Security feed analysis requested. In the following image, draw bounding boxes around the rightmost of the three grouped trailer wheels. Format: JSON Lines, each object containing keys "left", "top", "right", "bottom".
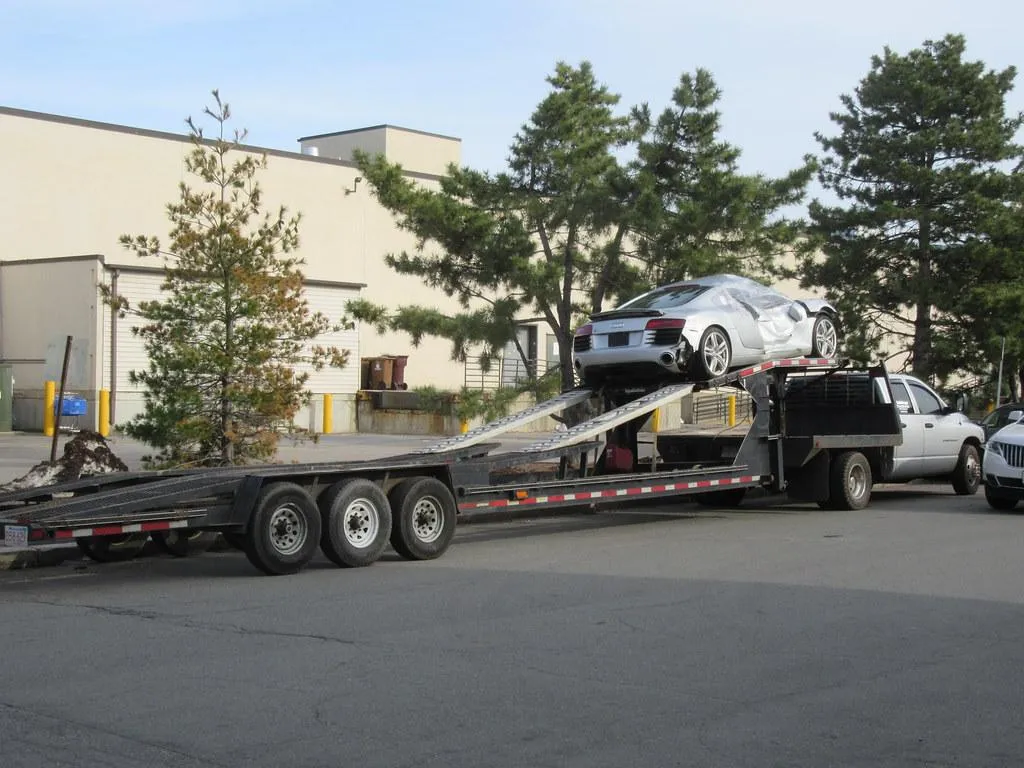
{"left": 389, "top": 477, "right": 456, "bottom": 560}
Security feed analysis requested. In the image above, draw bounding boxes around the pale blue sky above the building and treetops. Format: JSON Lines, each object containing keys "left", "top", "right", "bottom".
{"left": 0, "top": 0, "right": 1024, "bottom": 174}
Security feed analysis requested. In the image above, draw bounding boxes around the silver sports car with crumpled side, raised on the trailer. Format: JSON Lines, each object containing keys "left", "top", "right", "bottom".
{"left": 572, "top": 274, "right": 839, "bottom": 386}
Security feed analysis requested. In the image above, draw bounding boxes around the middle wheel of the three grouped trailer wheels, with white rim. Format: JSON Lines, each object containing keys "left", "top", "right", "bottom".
{"left": 316, "top": 477, "right": 391, "bottom": 568}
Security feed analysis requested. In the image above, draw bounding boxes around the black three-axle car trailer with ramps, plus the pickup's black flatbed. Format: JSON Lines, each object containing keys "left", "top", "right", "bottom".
{"left": 0, "top": 357, "right": 902, "bottom": 574}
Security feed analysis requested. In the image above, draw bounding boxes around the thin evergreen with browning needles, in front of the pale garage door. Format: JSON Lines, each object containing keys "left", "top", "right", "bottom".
{"left": 110, "top": 91, "right": 347, "bottom": 473}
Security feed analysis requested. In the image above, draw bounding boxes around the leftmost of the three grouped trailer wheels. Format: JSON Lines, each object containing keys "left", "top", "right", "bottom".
{"left": 246, "top": 482, "right": 321, "bottom": 575}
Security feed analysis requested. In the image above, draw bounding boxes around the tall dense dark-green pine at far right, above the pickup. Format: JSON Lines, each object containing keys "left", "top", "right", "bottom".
{"left": 805, "top": 35, "right": 1022, "bottom": 377}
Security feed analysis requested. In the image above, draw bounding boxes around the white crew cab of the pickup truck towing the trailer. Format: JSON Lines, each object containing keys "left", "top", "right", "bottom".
{"left": 881, "top": 374, "right": 983, "bottom": 496}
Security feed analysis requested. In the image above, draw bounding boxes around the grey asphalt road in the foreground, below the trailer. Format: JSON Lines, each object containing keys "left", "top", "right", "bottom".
{"left": 0, "top": 486, "right": 1024, "bottom": 768}
